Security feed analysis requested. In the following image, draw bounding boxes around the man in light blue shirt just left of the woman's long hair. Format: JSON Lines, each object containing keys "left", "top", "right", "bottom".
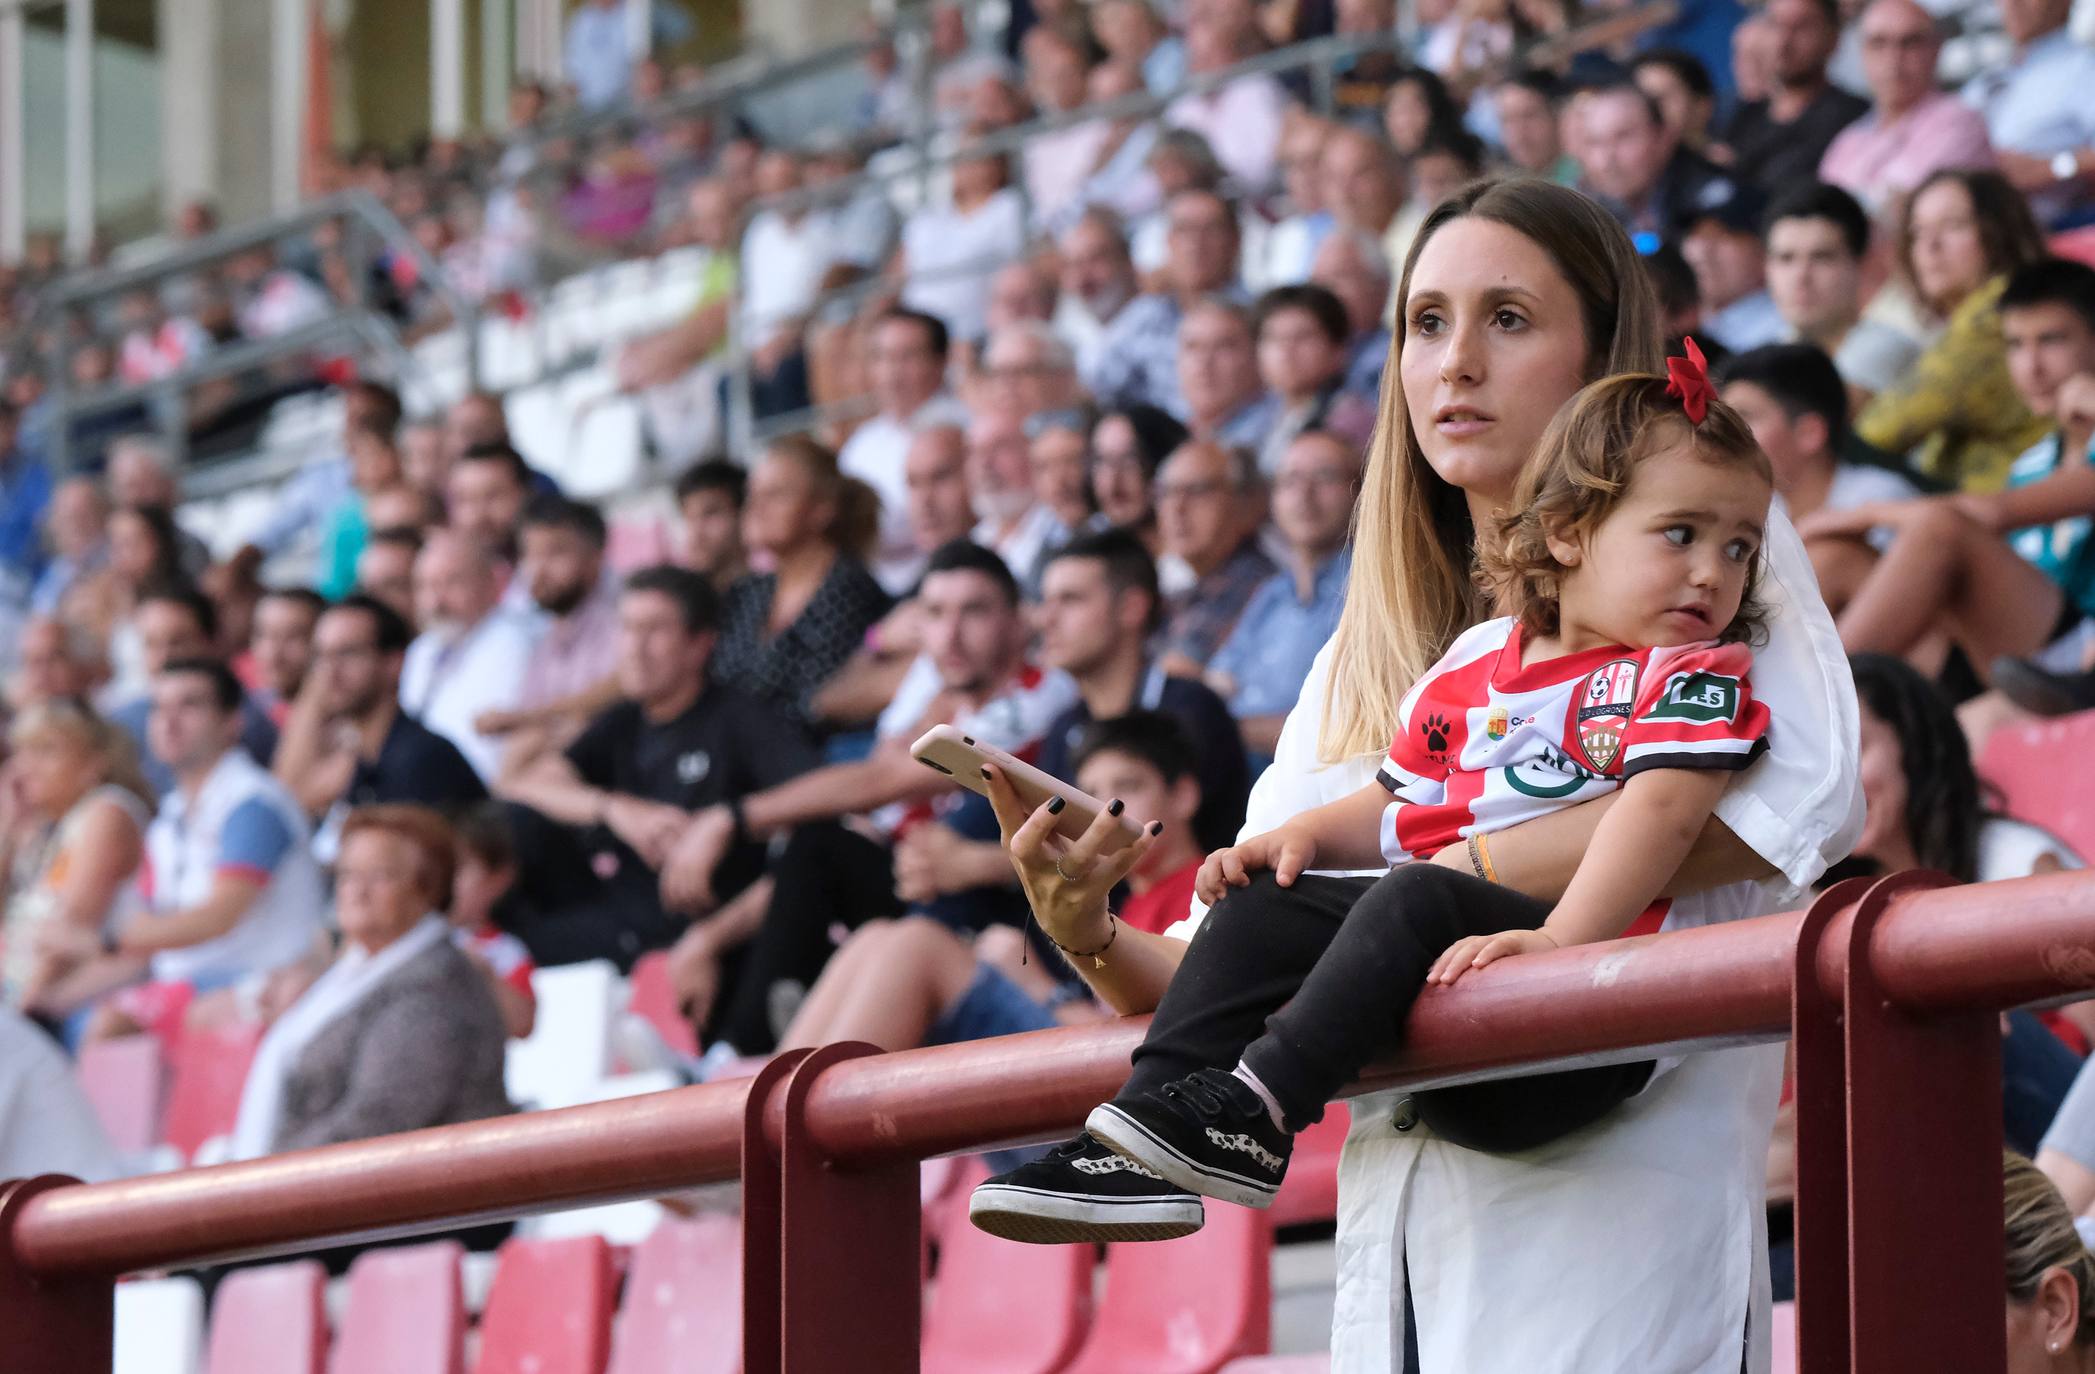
{"left": 1207, "top": 429, "right": 1362, "bottom": 760}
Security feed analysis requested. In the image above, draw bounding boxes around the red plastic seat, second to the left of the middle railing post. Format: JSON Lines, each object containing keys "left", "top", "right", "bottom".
{"left": 473, "top": 1236, "right": 618, "bottom": 1374}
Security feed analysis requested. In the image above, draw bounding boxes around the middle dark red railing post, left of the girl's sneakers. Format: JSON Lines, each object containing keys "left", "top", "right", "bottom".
{"left": 762, "top": 1043, "right": 924, "bottom": 1374}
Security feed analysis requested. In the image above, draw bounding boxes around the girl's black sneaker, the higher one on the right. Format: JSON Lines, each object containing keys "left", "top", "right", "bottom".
{"left": 1083, "top": 1068, "right": 1295, "bottom": 1206}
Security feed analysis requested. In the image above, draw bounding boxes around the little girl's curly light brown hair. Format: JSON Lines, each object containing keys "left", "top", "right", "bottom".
{"left": 1477, "top": 373, "right": 1774, "bottom": 643}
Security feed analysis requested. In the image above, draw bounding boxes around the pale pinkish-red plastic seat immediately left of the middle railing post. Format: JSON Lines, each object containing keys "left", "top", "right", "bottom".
{"left": 608, "top": 1217, "right": 742, "bottom": 1374}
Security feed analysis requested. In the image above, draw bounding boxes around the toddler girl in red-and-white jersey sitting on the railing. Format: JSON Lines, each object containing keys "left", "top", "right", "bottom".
{"left": 970, "top": 344, "right": 1772, "bottom": 1242}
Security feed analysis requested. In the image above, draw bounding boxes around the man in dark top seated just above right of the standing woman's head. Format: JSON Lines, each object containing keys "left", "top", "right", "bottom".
{"left": 1573, "top": 79, "right": 1743, "bottom": 239}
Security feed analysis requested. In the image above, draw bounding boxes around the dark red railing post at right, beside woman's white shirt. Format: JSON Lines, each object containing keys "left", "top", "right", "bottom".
{"left": 1843, "top": 873, "right": 2007, "bottom": 1374}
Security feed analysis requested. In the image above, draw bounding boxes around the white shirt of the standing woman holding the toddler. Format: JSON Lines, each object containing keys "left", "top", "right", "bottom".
{"left": 1169, "top": 513, "right": 1862, "bottom": 1374}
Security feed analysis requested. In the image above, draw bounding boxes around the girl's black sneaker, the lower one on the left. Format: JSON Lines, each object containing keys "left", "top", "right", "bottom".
{"left": 968, "top": 1135, "right": 1207, "bottom": 1244}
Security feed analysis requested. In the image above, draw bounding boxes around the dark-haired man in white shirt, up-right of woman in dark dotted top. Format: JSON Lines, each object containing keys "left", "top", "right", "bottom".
{"left": 836, "top": 308, "right": 966, "bottom": 591}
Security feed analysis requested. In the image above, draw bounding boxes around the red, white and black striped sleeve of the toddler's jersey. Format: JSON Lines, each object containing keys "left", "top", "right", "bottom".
{"left": 1622, "top": 643, "right": 1768, "bottom": 779}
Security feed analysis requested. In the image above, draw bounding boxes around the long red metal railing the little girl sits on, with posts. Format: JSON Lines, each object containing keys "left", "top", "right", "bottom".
{"left": 0, "top": 873, "right": 2095, "bottom": 1374}
